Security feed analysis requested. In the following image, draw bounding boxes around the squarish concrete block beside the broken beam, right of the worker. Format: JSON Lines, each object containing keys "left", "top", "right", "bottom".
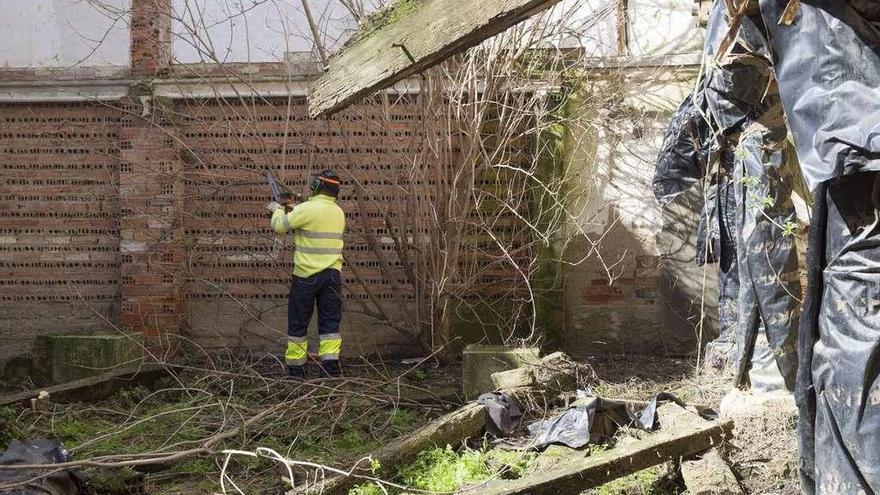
{"left": 462, "top": 345, "right": 540, "bottom": 400}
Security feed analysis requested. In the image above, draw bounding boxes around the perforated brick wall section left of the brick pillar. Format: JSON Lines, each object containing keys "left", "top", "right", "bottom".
{"left": 0, "top": 103, "right": 122, "bottom": 355}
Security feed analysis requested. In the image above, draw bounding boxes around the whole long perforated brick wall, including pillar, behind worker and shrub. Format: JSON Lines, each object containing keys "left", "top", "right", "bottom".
{"left": 0, "top": 91, "right": 526, "bottom": 357}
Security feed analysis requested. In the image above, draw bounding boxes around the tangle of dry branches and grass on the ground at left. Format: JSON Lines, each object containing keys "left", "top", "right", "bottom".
{"left": 0, "top": 363, "right": 439, "bottom": 494}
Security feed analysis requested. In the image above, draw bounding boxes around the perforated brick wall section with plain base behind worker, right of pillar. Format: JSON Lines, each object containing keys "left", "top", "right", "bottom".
{"left": 175, "top": 98, "right": 430, "bottom": 354}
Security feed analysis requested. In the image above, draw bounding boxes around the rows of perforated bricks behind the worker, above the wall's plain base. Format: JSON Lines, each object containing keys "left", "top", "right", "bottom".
{"left": 178, "top": 99, "right": 420, "bottom": 306}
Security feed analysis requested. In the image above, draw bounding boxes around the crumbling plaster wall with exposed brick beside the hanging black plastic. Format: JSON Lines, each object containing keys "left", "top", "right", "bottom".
{"left": 564, "top": 67, "right": 717, "bottom": 354}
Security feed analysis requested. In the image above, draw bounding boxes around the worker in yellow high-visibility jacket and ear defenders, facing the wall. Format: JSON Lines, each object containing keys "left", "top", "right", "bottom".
{"left": 269, "top": 170, "right": 345, "bottom": 378}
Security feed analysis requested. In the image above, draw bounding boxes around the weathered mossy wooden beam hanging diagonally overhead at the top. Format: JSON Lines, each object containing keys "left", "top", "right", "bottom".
{"left": 308, "top": 0, "right": 559, "bottom": 117}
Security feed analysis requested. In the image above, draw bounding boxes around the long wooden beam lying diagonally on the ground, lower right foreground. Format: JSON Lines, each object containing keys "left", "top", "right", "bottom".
{"left": 463, "top": 404, "right": 733, "bottom": 495}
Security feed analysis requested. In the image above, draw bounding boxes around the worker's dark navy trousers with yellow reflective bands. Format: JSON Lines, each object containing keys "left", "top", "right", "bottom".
{"left": 287, "top": 268, "right": 342, "bottom": 364}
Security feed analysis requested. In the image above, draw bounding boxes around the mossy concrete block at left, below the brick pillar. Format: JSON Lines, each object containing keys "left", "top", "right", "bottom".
{"left": 34, "top": 334, "right": 144, "bottom": 383}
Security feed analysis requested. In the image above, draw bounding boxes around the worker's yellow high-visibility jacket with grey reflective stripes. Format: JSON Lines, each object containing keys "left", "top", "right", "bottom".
{"left": 272, "top": 194, "right": 345, "bottom": 277}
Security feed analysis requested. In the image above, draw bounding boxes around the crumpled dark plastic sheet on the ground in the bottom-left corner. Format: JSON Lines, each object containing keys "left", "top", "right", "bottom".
{"left": 0, "top": 440, "right": 80, "bottom": 495}
